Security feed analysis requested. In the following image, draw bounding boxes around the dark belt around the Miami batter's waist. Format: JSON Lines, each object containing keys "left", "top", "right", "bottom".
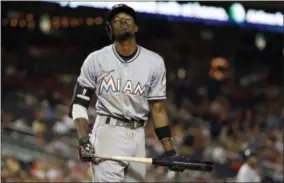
{"left": 103, "top": 116, "right": 146, "bottom": 129}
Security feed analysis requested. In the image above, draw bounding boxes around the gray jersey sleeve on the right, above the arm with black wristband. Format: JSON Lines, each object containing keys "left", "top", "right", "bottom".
{"left": 148, "top": 59, "right": 167, "bottom": 100}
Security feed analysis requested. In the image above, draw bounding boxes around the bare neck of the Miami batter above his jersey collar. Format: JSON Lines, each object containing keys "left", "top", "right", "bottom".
{"left": 114, "top": 39, "right": 137, "bottom": 56}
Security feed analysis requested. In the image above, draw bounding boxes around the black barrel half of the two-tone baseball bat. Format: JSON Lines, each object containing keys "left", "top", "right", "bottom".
{"left": 153, "top": 158, "right": 214, "bottom": 172}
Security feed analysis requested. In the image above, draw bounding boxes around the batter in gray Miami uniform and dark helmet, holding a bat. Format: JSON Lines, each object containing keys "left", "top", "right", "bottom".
{"left": 69, "top": 4, "right": 184, "bottom": 182}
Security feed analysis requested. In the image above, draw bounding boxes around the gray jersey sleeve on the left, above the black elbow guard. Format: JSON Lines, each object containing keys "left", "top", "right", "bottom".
{"left": 78, "top": 54, "right": 97, "bottom": 89}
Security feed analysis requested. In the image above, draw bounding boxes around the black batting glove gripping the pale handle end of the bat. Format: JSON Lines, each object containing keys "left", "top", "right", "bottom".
{"left": 79, "top": 136, "right": 95, "bottom": 162}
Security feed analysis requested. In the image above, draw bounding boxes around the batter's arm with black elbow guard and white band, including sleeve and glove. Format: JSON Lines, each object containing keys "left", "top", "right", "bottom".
{"left": 69, "top": 54, "right": 96, "bottom": 162}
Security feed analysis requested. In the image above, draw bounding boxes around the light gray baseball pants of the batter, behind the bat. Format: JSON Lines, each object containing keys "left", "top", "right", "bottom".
{"left": 90, "top": 115, "right": 146, "bottom": 182}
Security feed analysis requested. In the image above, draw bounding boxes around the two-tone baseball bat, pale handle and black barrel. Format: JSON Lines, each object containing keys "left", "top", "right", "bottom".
{"left": 93, "top": 154, "right": 214, "bottom": 172}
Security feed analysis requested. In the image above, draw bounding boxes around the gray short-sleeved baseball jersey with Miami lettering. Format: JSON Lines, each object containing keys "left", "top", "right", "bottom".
{"left": 78, "top": 44, "right": 166, "bottom": 120}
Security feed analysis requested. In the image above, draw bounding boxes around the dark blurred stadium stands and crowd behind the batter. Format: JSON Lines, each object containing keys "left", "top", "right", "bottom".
{"left": 1, "top": 2, "right": 284, "bottom": 182}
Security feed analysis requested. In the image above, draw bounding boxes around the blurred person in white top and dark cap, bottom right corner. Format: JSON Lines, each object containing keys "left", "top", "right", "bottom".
{"left": 236, "top": 149, "right": 261, "bottom": 182}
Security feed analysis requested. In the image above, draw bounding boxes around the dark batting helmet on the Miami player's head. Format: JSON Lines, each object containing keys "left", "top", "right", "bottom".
{"left": 106, "top": 4, "right": 136, "bottom": 41}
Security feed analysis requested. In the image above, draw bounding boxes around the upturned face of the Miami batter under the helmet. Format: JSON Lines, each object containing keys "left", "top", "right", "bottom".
{"left": 112, "top": 13, "right": 138, "bottom": 39}
